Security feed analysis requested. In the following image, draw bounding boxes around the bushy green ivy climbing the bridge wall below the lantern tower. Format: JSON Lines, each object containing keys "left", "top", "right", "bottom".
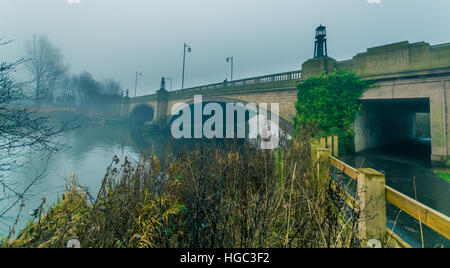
{"left": 294, "top": 71, "right": 373, "bottom": 154}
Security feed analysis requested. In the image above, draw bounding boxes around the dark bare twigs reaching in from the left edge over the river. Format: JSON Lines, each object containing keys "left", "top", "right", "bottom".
{"left": 0, "top": 38, "right": 73, "bottom": 231}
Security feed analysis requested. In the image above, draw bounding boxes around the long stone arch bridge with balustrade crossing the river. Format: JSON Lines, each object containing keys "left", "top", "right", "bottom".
{"left": 120, "top": 41, "right": 450, "bottom": 164}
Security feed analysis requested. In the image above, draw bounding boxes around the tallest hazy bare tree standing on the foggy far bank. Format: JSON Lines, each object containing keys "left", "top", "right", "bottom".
{"left": 26, "top": 35, "right": 68, "bottom": 101}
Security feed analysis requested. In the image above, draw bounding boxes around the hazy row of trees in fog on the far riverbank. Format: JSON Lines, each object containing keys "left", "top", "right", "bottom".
{"left": 26, "top": 35, "right": 124, "bottom": 107}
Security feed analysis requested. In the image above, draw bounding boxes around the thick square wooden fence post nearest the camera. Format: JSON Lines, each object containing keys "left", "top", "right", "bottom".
{"left": 358, "top": 168, "right": 386, "bottom": 247}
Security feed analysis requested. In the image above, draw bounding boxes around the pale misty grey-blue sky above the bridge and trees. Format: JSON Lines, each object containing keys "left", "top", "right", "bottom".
{"left": 0, "top": 0, "right": 450, "bottom": 95}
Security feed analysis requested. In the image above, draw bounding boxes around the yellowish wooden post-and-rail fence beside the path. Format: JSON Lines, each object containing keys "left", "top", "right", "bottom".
{"left": 311, "top": 136, "right": 450, "bottom": 248}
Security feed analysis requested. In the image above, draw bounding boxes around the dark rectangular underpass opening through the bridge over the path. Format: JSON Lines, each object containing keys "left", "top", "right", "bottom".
{"left": 355, "top": 98, "right": 431, "bottom": 165}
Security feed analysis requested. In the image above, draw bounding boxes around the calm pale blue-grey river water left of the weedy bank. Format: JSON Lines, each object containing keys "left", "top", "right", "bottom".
{"left": 0, "top": 122, "right": 156, "bottom": 235}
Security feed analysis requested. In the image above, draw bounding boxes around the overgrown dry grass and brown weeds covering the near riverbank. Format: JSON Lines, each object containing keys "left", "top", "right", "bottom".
{"left": 0, "top": 133, "right": 359, "bottom": 248}
